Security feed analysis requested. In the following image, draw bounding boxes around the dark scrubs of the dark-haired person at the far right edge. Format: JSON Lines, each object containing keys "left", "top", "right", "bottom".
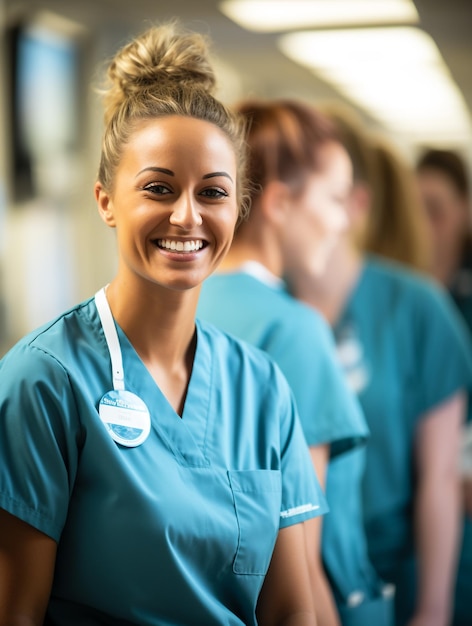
{"left": 450, "top": 257, "right": 472, "bottom": 626}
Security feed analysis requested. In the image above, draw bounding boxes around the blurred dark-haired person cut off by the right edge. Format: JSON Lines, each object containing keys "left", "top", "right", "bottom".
{"left": 416, "top": 148, "right": 472, "bottom": 626}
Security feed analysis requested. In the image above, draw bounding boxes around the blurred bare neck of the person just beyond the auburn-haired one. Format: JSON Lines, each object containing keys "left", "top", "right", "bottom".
{"left": 289, "top": 238, "right": 363, "bottom": 325}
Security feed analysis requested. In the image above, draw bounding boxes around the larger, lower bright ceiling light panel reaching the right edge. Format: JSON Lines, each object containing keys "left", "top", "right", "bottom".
{"left": 279, "top": 27, "right": 471, "bottom": 141}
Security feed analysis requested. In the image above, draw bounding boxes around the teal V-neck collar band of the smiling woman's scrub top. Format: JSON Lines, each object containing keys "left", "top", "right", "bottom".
{"left": 115, "top": 321, "right": 212, "bottom": 467}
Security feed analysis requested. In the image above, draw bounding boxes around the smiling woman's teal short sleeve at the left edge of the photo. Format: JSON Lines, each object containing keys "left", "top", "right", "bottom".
{"left": 0, "top": 344, "right": 80, "bottom": 540}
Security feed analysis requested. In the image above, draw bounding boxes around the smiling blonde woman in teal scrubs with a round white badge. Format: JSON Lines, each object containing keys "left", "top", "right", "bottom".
{"left": 0, "top": 19, "right": 327, "bottom": 626}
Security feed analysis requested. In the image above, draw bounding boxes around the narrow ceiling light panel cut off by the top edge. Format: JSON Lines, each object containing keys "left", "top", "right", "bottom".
{"left": 219, "top": 0, "right": 419, "bottom": 32}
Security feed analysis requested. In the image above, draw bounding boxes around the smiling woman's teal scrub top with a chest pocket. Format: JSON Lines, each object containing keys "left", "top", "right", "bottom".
{"left": 0, "top": 300, "right": 327, "bottom": 626}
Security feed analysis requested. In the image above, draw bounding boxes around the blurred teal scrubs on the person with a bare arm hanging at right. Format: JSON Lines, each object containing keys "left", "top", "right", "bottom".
{"left": 334, "top": 258, "right": 472, "bottom": 625}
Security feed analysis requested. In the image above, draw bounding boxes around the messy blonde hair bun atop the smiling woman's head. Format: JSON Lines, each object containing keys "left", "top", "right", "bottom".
{"left": 108, "top": 22, "right": 215, "bottom": 103}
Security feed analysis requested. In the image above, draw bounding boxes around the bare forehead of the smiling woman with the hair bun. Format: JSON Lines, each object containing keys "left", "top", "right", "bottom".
{"left": 122, "top": 115, "right": 236, "bottom": 175}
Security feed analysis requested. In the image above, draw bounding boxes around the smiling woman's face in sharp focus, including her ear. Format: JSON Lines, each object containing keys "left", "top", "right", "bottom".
{"left": 96, "top": 116, "right": 238, "bottom": 290}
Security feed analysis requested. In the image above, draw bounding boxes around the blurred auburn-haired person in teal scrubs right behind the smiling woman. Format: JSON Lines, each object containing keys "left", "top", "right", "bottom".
{"left": 198, "top": 100, "right": 392, "bottom": 626}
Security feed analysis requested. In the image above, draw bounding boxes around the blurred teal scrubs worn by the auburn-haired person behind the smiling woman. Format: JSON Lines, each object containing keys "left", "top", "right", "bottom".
{"left": 197, "top": 262, "right": 392, "bottom": 626}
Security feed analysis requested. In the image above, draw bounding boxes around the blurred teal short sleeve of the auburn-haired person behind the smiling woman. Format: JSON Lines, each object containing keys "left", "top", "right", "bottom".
{"left": 268, "top": 307, "right": 368, "bottom": 458}
